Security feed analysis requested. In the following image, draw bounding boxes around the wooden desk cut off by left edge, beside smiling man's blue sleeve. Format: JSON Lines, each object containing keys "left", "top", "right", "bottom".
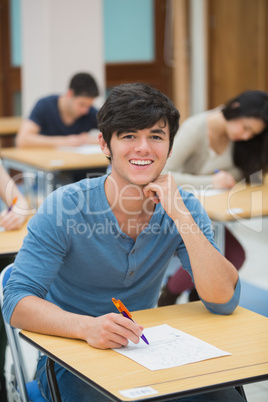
{"left": 0, "top": 220, "right": 28, "bottom": 257}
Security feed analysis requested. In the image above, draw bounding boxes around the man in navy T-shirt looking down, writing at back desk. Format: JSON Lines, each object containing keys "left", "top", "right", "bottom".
{"left": 16, "top": 73, "right": 99, "bottom": 147}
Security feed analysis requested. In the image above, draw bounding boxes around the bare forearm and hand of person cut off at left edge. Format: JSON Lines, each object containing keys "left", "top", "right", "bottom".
{"left": 0, "top": 165, "right": 29, "bottom": 230}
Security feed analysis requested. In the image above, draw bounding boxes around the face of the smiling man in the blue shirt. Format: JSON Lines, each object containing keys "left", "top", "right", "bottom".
{"left": 103, "top": 121, "right": 170, "bottom": 186}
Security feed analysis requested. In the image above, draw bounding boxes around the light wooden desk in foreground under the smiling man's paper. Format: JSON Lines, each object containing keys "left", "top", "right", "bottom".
{"left": 20, "top": 302, "right": 268, "bottom": 401}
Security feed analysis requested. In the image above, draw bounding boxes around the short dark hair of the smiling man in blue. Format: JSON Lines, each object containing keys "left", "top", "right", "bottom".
{"left": 97, "top": 83, "right": 180, "bottom": 155}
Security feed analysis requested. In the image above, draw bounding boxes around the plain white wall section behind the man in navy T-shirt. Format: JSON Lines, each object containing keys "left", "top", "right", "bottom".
{"left": 21, "top": 0, "right": 105, "bottom": 116}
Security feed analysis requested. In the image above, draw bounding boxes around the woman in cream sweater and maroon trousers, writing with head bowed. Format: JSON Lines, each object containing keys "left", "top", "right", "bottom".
{"left": 158, "top": 90, "right": 268, "bottom": 306}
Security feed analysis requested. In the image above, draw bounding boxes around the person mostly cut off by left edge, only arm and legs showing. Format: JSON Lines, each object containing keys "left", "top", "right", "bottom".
{"left": 0, "top": 160, "right": 29, "bottom": 402}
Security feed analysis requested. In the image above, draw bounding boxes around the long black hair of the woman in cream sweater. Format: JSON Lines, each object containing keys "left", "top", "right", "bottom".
{"left": 222, "top": 90, "right": 268, "bottom": 182}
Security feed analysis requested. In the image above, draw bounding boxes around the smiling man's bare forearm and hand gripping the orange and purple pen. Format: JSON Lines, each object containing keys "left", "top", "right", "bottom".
{"left": 10, "top": 296, "right": 143, "bottom": 349}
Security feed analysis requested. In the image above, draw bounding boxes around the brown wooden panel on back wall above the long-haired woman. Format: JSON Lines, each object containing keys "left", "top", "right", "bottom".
{"left": 208, "top": 0, "right": 268, "bottom": 108}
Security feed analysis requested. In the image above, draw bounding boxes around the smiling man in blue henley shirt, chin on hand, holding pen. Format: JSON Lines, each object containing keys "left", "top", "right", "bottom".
{"left": 3, "top": 84, "right": 244, "bottom": 402}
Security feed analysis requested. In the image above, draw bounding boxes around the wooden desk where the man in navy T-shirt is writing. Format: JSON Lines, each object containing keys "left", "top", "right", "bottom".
{"left": 1, "top": 148, "right": 109, "bottom": 197}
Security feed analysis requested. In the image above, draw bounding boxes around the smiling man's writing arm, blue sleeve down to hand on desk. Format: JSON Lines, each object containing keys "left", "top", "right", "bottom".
{"left": 3, "top": 192, "right": 143, "bottom": 349}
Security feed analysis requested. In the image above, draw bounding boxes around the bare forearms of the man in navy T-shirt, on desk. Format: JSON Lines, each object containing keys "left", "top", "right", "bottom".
{"left": 16, "top": 119, "right": 99, "bottom": 148}
